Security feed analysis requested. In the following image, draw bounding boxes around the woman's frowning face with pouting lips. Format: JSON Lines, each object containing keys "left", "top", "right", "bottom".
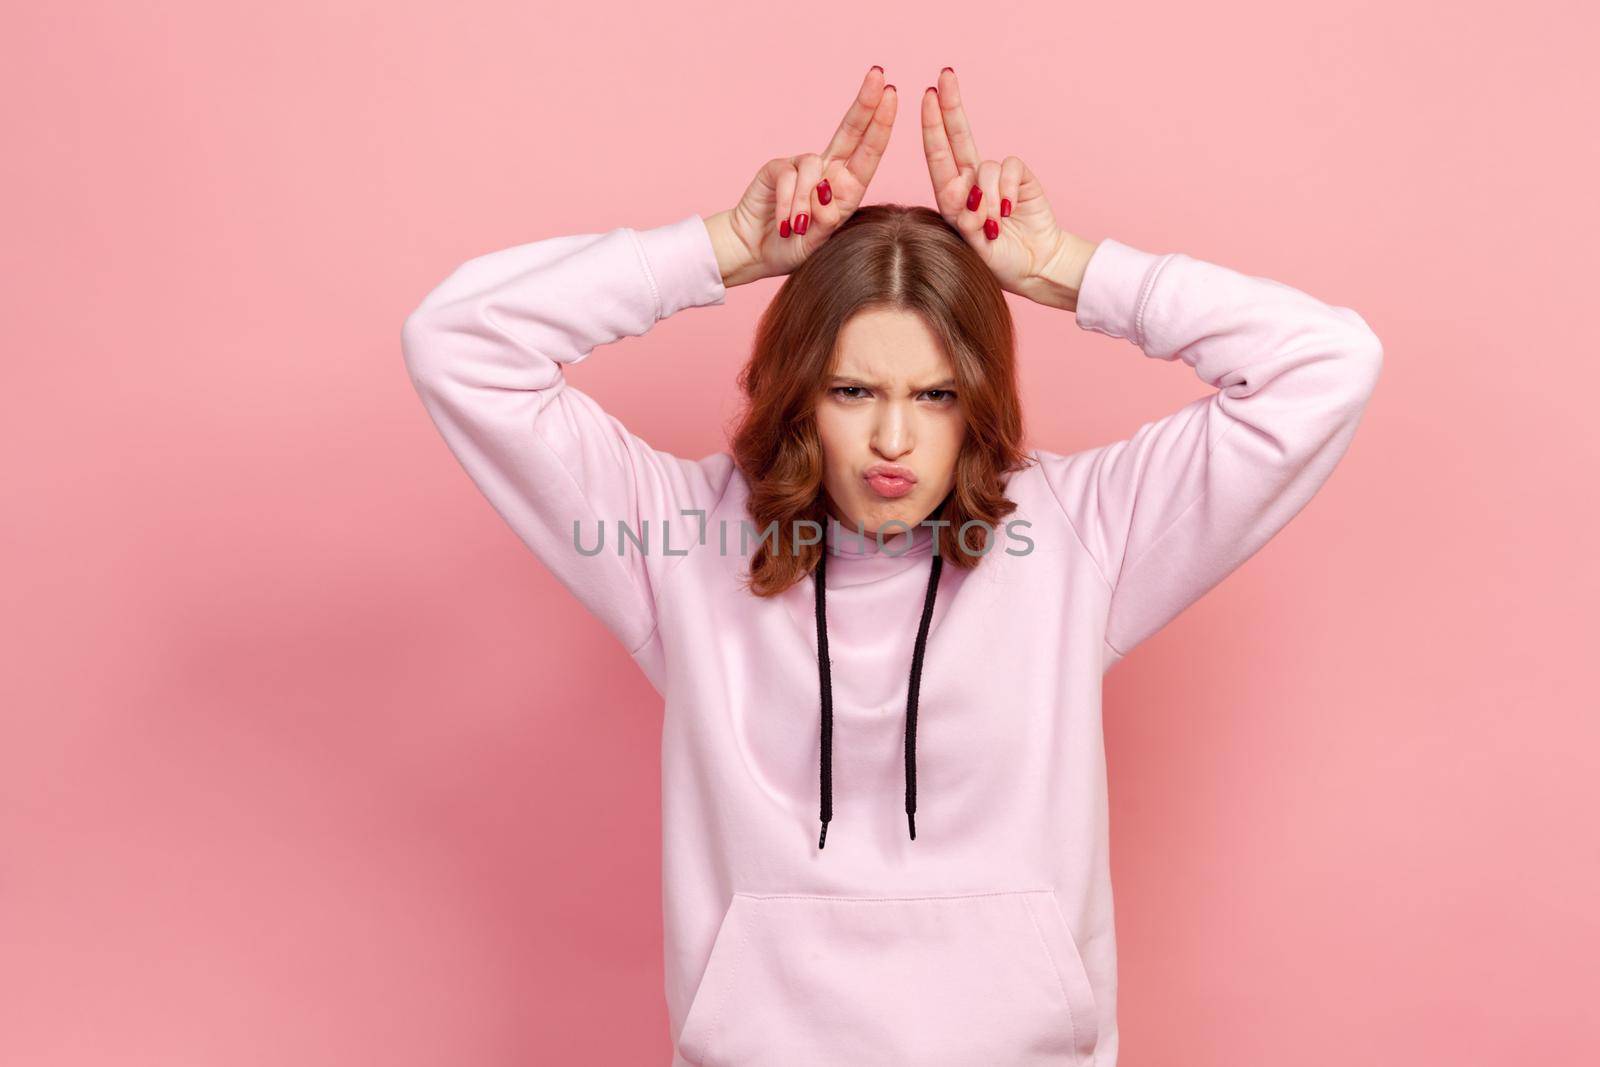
{"left": 816, "top": 309, "right": 966, "bottom": 545}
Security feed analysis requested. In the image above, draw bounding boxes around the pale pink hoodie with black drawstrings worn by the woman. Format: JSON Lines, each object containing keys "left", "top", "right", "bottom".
{"left": 403, "top": 216, "right": 1382, "bottom": 1067}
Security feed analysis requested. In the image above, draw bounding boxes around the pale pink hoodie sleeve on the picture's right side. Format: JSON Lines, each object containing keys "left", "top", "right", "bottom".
{"left": 1040, "top": 240, "right": 1382, "bottom": 667}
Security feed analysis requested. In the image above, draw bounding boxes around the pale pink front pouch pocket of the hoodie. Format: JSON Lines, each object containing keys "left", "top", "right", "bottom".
{"left": 678, "top": 889, "right": 1098, "bottom": 1067}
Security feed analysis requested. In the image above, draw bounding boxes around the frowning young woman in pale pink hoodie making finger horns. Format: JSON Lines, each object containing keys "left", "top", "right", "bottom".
{"left": 405, "top": 67, "right": 1382, "bottom": 1067}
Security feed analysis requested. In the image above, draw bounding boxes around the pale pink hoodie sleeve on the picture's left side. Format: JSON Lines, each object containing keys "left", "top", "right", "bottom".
{"left": 402, "top": 214, "right": 733, "bottom": 656}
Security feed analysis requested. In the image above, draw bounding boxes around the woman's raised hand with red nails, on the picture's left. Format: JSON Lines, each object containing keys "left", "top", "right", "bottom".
{"left": 706, "top": 67, "right": 896, "bottom": 288}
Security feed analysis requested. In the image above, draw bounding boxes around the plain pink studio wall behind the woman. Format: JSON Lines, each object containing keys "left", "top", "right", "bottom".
{"left": 0, "top": 0, "right": 1600, "bottom": 1067}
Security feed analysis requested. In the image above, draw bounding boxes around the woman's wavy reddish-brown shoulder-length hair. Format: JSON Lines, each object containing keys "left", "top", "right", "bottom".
{"left": 731, "top": 203, "right": 1027, "bottom": 597}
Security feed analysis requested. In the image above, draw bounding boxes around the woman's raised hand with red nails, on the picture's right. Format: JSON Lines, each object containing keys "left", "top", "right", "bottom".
{"left": 922, "top": 67, "right": 1096, "bottom": 310}
